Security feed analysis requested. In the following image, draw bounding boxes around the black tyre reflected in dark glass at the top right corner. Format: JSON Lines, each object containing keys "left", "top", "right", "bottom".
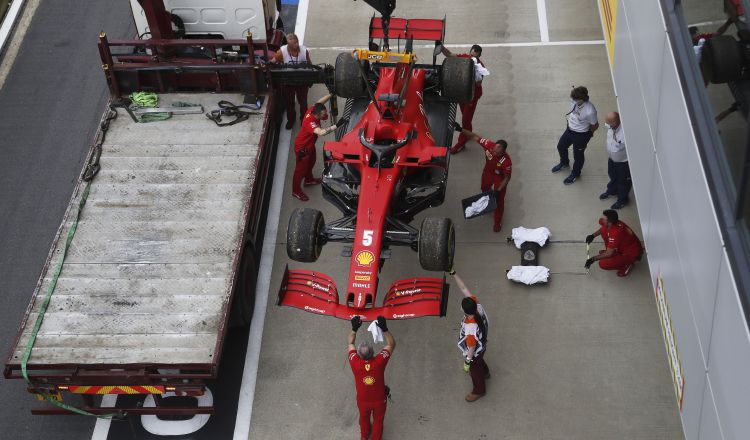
{"left": 701, "top": 35, "right": 742, "bottom": 84}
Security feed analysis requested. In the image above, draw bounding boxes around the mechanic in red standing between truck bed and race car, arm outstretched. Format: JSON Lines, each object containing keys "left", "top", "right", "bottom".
{"left": 292, "top": 95, "right": 349, "bottom": 202}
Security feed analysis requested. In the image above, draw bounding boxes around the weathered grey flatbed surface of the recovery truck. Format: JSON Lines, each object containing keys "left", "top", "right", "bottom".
{"left": 6, "top": 93, "right": 266, "bottom": 370}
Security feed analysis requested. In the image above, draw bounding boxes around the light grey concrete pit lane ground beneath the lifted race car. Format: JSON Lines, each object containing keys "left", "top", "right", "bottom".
{"left": 250, "top": 0, "right": 682, "bottom": 439}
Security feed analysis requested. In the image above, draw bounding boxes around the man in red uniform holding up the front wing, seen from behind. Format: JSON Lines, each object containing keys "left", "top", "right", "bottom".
{"left": 348, "top": 316, "right": 396, "bottom": 440}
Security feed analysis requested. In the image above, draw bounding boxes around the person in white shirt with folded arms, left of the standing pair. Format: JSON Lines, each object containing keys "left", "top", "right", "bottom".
{"left": 552, "top": 86, "right": 599, "bottom": 185}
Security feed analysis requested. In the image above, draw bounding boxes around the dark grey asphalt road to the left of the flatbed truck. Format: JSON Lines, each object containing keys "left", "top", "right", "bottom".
{"left": 0, "top": 0, "right": 129, "bottom": 440}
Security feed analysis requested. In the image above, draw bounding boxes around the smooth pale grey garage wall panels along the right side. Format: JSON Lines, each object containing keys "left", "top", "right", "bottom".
{"left": 599, "top": 0, "right": 750, "bottom": 440}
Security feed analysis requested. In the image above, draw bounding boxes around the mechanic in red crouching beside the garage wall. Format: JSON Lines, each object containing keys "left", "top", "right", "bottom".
{"left": 584, "top": 209, "right": 643, "bottom": 277}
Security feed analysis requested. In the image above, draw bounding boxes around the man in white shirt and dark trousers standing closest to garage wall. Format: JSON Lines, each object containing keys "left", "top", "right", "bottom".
{"left": 599, "top": 112, "right": 633, "bottom": 209}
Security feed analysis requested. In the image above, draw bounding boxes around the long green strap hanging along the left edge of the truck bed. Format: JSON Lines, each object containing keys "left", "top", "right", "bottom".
{"left": 21, "top": 182, "right": 115, "bottom": 419}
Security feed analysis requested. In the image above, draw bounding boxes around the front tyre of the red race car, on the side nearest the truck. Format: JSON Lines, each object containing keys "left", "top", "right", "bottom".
{"left": 286, "top": 208, "right": 325, "bottom": 263}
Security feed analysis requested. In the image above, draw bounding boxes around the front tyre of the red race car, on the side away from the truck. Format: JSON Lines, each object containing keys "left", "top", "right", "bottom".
{"left": 418, "top": 217, "right": 456, "bottom": 271}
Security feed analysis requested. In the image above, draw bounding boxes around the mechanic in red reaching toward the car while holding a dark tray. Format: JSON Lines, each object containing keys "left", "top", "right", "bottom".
{"left": 453, "top": 122, "right": 513, "bottom": 232}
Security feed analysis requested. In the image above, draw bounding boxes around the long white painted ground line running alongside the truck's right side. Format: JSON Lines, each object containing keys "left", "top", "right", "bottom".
{"left": 234, "top": 117, "right": 302, "bottom": 440}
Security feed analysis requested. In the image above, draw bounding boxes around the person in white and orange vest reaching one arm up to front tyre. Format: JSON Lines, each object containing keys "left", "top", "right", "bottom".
{"left": 448, "top": 270, "right": 490, "bottom": 402}
